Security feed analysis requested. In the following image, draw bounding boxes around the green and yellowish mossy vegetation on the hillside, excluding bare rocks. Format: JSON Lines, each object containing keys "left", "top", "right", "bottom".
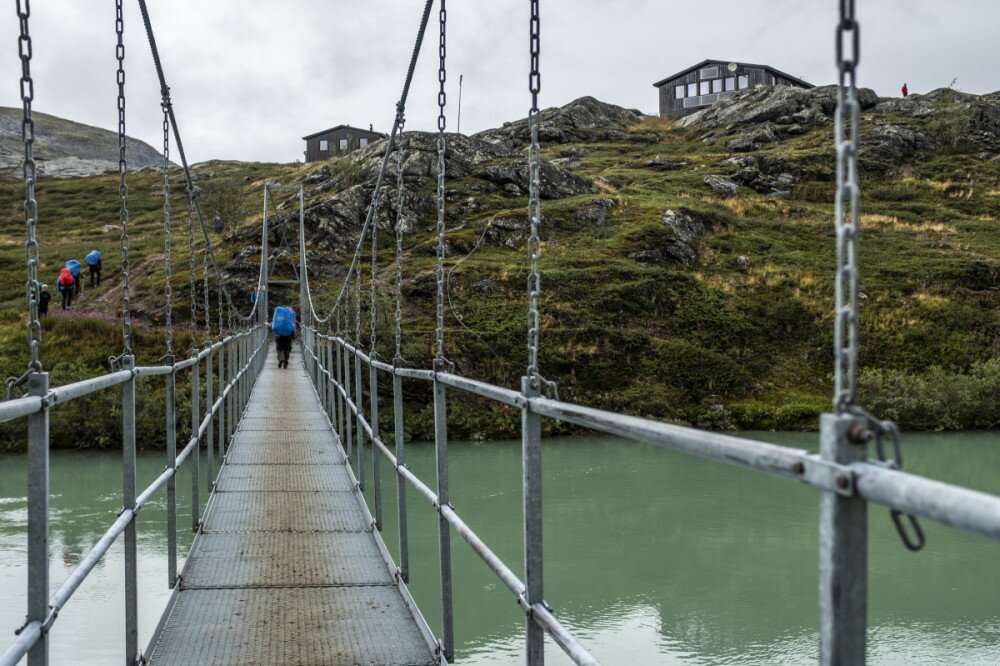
{"left": 0, "top": 110, "right": 1000, "bottom": 447}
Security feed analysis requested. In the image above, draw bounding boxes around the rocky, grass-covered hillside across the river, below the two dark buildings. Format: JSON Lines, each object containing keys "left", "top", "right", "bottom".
{"left": 0, "top": 88, "right": 1000, "bottom": 442}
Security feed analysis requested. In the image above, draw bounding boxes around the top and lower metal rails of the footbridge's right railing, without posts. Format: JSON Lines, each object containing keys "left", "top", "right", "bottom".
{"left": 303, "top": 327, "right": 1000, "bottom": 664}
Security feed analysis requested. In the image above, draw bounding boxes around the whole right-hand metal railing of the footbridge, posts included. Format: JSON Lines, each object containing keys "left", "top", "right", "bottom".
{"left": 302, "top": 327, "right": 1000, "bottom": 664}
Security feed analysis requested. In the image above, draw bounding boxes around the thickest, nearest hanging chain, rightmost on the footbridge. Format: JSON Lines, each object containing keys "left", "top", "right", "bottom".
{"left": 833, "top": 0, "right": 860, "bottom": 414}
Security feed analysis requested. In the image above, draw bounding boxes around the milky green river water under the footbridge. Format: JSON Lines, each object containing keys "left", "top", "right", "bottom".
{"left": 0, "top": 433, "right": 1000, "bottom": 666}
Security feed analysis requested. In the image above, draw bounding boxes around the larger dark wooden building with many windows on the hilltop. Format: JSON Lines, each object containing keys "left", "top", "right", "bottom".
{"left": 653, "top": 60, "right": 814, "bottom": 117}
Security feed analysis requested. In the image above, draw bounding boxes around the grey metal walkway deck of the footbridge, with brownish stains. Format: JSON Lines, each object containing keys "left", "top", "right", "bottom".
{"left": 149, "top": 353, "right": 437, "bottom": 666}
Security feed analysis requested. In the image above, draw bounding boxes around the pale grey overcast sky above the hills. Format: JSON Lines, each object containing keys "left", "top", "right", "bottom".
{"left": 0, "top": 0, "right": 1000, "bottom": 162}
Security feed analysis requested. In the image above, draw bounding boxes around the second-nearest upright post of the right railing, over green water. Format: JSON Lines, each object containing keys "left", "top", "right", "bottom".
{"left": 521, "top": 377, "right": 545, "bottom": 666}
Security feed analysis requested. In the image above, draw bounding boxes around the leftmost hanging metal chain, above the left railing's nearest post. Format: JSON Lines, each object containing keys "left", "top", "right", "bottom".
{"left": 16, "top": 0, "right": 42, "bottom": 374}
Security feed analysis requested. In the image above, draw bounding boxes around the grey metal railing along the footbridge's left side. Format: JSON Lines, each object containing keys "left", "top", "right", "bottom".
{"left": 0, "top": 325, "right": 267, "bottom": 666}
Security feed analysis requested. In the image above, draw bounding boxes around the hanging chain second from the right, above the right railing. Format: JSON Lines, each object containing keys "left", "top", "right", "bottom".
{"left": 527, "top": 0, "right": 556, "bottom": 393}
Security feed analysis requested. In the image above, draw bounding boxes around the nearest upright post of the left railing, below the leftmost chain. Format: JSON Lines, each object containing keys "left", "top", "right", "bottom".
{"left": 27, "top": 372, "right": 49, "bottom": 666}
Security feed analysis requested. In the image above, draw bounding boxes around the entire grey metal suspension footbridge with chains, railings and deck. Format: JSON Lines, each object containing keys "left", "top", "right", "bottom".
{"left": 0, "top": 0, "right": 1000, "bottom": 666}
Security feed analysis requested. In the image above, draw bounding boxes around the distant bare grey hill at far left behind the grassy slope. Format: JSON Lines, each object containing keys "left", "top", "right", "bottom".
{"left": 0, "top": 107, "right": 163, "bottom": 178}
